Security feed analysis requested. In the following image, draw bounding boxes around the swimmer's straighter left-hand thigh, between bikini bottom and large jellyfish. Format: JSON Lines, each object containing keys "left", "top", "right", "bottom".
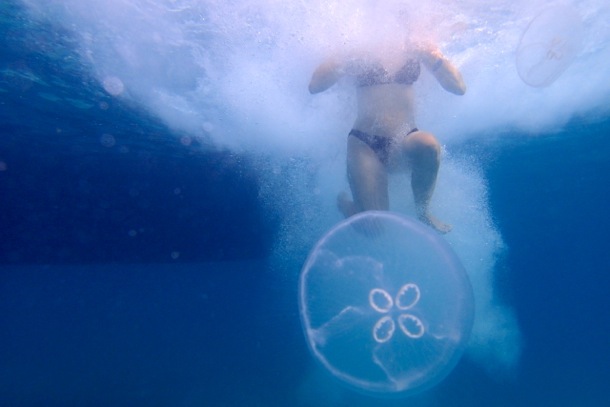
{"left": 347, "top": 136, "right": 389, "bottom": 211}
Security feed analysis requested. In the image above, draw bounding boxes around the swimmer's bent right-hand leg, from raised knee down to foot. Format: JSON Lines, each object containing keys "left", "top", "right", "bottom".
{"left": 398, "top": 131, "right": 451, "bottom": 233}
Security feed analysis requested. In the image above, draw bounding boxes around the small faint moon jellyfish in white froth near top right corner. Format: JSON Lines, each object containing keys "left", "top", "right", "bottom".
{"left": 516, "top": 6, "right": 583, "bottom": 87}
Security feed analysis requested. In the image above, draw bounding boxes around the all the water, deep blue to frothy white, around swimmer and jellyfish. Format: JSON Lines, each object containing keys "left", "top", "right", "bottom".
{"left": 0, "top": 0, "right": 610, "bottom": 407}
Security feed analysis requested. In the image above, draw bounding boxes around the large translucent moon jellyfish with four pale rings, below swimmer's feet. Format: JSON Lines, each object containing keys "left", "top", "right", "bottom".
{"left": 299, "top": 211, "right": 474, "bottom": 396}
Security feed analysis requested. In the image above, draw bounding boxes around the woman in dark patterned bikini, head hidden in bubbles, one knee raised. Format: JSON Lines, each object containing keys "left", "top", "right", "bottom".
{"left": 309, "top": 44, "right": 466, "bottom": 233}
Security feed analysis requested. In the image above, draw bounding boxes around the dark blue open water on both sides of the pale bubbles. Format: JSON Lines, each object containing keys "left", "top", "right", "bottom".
{"left": 0, "top": 2, "right": 610, "bottom": 407}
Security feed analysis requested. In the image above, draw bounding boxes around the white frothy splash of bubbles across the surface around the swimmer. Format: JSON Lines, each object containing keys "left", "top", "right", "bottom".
{"left": 23, "top": 0, "right": 610, "bottom": 145}
